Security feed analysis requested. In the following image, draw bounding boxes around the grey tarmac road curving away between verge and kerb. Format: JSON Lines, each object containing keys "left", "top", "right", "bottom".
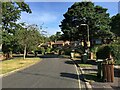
{"left": 2, "top": 57, "right": 79, "bottom": 88}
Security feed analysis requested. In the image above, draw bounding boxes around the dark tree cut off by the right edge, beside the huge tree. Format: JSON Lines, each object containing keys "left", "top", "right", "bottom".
{"left": 110, "top": 14, "right": 120, "bottom": 37}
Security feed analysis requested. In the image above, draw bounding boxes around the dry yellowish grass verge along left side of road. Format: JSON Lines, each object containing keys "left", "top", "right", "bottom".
{"left": 0, "top": 58, "right": 41, "bottom": 74}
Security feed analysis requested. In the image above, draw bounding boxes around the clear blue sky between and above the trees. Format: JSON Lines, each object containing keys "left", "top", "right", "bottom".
{"left": 19, "top": 2, "right": 118, "bottom": 35}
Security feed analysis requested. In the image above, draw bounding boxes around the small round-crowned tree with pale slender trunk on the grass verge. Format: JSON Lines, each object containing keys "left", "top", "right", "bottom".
{"left": 15, "top": 25, "right": 41, "bottom": 59}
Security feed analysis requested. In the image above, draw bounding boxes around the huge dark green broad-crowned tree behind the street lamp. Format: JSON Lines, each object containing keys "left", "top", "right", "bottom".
{"left": 60, "top": 2, "right": 111, "bottom": 41}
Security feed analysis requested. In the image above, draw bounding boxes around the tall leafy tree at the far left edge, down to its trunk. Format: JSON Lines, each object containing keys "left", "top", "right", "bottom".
{"left": 1, "top": 1, "right": 31, "bottom": 58}
